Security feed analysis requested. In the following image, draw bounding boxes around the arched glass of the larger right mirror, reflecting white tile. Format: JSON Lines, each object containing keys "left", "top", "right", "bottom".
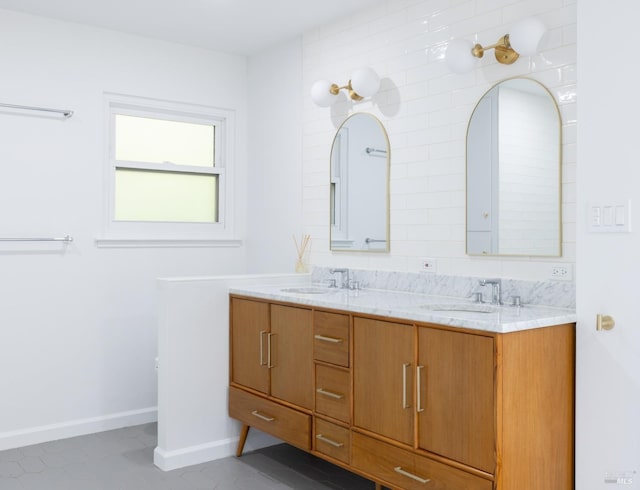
{"left": 467, "top": 78, "right": 562, "bottom": 256}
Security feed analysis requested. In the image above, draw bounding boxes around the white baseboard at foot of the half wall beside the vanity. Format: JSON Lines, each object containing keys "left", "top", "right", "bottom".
{"left": 153, "top": 429, "right": 282, "bottom": 471}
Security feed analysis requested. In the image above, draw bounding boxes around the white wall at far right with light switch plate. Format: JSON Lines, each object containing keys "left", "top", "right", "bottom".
{"left": 576, "top": 0, "right": 640, "bottom": 490}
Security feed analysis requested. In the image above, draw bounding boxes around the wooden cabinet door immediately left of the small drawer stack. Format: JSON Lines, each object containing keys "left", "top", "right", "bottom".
{"left": 270, "top": 305, "right": 313, "bottom": 410}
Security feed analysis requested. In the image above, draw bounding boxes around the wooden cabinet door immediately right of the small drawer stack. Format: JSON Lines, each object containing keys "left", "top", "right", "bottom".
{"left": 353, "top": 318, "right": 415, "bottom": 445}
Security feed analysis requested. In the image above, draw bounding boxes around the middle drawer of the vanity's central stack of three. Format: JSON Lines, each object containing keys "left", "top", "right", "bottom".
{"left": 315, "top": 364, "right": 351, "bottom": 422}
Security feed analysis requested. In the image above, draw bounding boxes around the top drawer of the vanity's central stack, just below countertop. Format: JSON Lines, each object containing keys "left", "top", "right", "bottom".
{"left": 313, "top": 311, "right": 349, "bottom": 367}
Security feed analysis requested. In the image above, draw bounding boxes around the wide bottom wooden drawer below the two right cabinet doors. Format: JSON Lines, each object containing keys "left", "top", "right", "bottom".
{"left": 351, "top": 433, "right": 493, "bottom": 490}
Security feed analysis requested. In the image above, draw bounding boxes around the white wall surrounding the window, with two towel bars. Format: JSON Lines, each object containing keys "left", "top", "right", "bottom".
{"left": 0, "top": 11, "right": 247, "bottom": 449}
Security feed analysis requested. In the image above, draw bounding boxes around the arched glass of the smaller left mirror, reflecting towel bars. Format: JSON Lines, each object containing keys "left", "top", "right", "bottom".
{"left": 330, "top": 113, "right": 390, "bottom": 252}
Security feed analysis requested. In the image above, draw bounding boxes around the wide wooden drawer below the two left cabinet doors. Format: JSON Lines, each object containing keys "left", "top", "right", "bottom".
{"left": 229, "top": 387, "right": 311, "bottom": 451}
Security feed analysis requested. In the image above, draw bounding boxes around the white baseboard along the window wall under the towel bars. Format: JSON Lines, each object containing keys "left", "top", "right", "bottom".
{"left": 0, "top": 407, "right": 158, "bottom": 451}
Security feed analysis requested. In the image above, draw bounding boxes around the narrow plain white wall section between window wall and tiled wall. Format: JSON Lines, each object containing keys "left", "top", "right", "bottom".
{"left": 246, "top": 38, "right": 304, "bottom": 272}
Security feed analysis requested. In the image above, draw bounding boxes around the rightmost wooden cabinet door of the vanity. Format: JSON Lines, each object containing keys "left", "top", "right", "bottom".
{"left": 417, "top": 327, "right": 496, "bottom": 473}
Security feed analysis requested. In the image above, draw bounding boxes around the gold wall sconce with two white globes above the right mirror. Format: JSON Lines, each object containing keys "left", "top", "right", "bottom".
{"left": 445, "top": 17, "right": 547, "bottom": 73}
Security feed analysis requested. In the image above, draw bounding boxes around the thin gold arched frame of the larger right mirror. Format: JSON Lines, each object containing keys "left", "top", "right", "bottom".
{"left": 464, "top": 76, "right": 564, "bottom": 257}
